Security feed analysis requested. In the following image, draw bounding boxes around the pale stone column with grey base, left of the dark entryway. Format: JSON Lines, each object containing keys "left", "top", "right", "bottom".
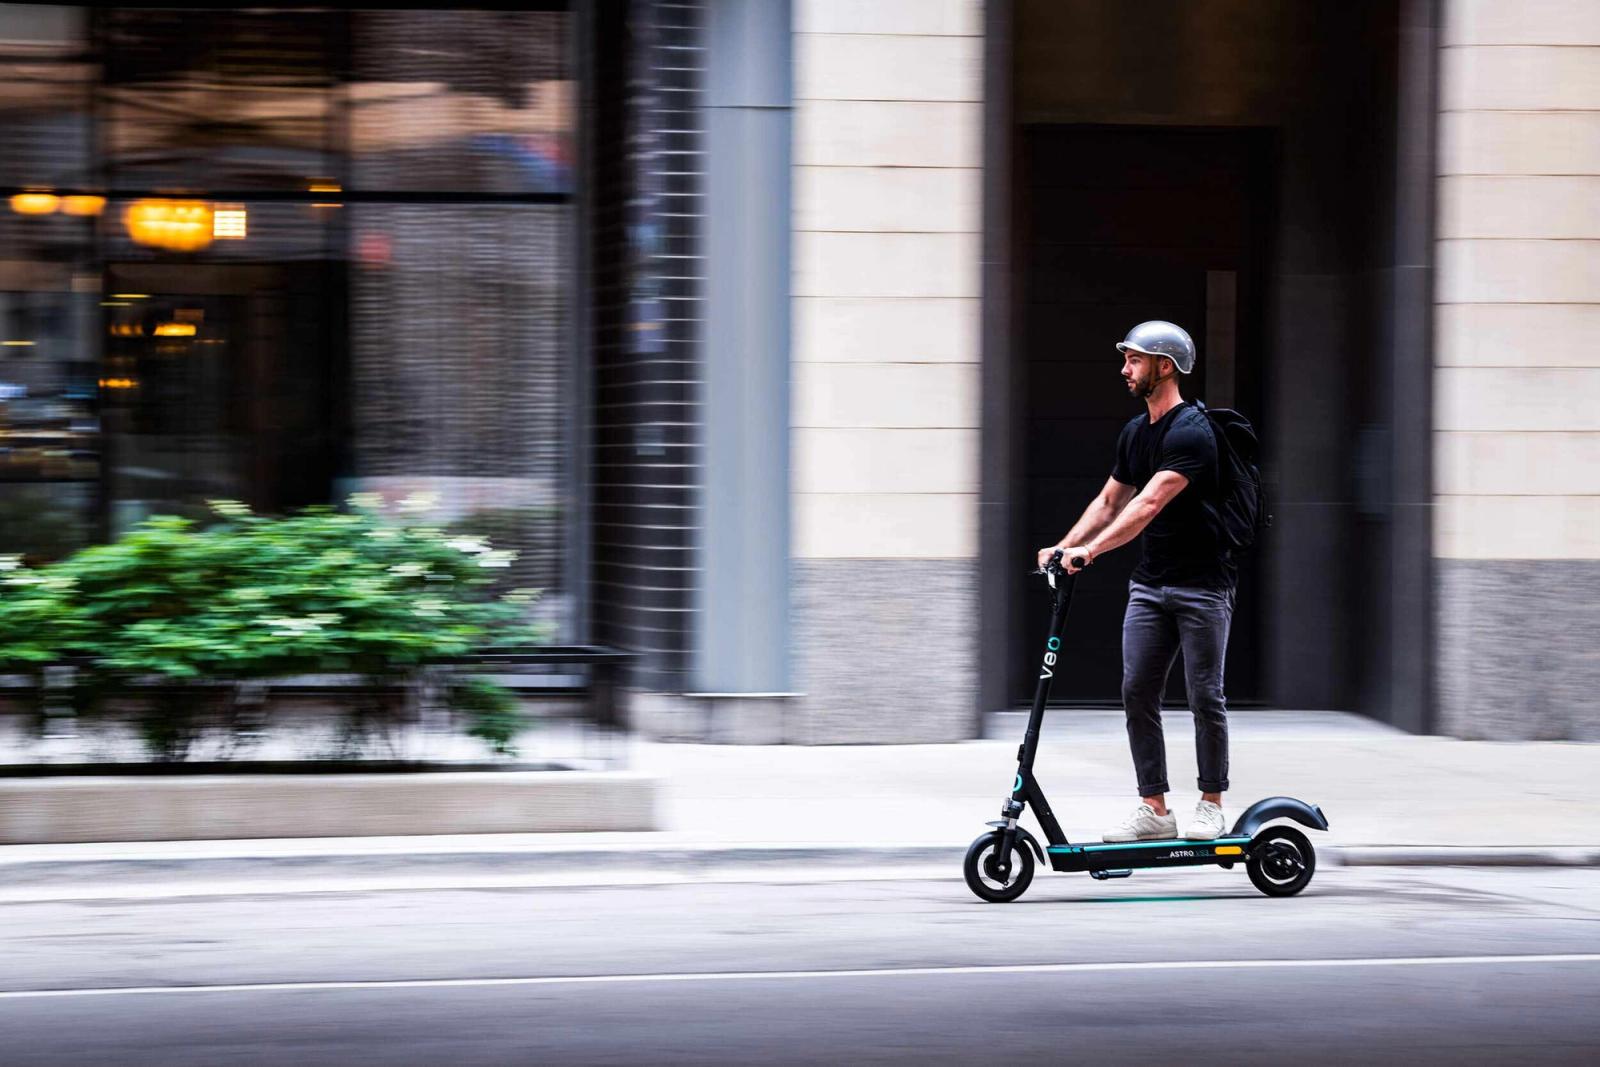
{"left": 786, "top": 0, "right": 982, "bottom": 742}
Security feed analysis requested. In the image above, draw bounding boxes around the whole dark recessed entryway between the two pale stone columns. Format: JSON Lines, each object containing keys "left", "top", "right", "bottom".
{"left": 981, "top": 0, "right": 1437, "bottom": 729}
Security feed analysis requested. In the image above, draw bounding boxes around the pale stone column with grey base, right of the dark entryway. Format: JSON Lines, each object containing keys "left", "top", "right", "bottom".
{"left": 1434, "top": 0, "right": 1600, "bottom": 741}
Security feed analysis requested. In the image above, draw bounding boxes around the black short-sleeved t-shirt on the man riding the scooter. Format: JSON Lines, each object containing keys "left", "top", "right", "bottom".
{"left": 1110, "top": 402, "right": 1238, "bottom": 589}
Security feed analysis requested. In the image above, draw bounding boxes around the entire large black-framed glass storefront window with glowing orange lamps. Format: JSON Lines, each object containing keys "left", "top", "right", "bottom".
{"left": 0, "top": 5, "right": 574, "bottom": 633}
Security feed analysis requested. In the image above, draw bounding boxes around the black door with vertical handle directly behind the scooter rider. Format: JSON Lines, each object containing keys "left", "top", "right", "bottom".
{"left": 1011, "top": 125, "right": 1274, "bottom": 705}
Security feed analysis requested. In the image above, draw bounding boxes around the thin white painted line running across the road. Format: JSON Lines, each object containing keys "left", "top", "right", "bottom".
{"left": 0, "top": 952, "right": 1600, "bottom": 1000}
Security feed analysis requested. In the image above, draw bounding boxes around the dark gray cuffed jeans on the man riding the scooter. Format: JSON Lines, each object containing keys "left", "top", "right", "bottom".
{"left": 1122, "top": 582, "right": 1234, "bottom": 797}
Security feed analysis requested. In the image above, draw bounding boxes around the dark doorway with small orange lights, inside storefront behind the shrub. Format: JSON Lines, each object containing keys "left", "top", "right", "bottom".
{"left": 101, "top": 262, "right": 347, "bottom": 533}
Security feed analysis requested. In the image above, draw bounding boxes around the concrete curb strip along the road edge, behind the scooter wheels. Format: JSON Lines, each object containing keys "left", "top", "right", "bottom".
{"left": 0, "top": 841, "right": 1600, "bottom": 888}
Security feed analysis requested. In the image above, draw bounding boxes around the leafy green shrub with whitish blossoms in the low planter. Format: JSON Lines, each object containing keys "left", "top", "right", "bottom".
{"left": 0, "top": 496, "right": 546, "bottom": 758}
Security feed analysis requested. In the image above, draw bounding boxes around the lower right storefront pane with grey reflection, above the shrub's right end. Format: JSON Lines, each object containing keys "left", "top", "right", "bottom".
{"left": 347, "top": 205, "right": 571, "bottom": 617}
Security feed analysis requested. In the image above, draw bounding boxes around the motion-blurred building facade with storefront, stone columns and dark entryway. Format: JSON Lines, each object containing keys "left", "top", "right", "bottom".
{"left": 0, "top": 0, "right": 1600, "bottom": 742}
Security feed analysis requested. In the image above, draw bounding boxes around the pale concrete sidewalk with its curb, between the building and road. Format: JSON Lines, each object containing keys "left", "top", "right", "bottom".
{"left": 0, "top": 710, "right": 1600, "bottom": 889}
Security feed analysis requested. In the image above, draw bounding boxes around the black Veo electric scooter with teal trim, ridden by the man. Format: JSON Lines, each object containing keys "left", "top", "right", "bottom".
{"left": 962, "top": 550, "right": 1328, "bottom": 904}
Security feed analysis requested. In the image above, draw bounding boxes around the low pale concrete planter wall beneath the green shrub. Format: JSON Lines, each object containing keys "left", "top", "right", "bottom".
{"left": 0, "top": 771, "right": 658, "bottom": 845}
